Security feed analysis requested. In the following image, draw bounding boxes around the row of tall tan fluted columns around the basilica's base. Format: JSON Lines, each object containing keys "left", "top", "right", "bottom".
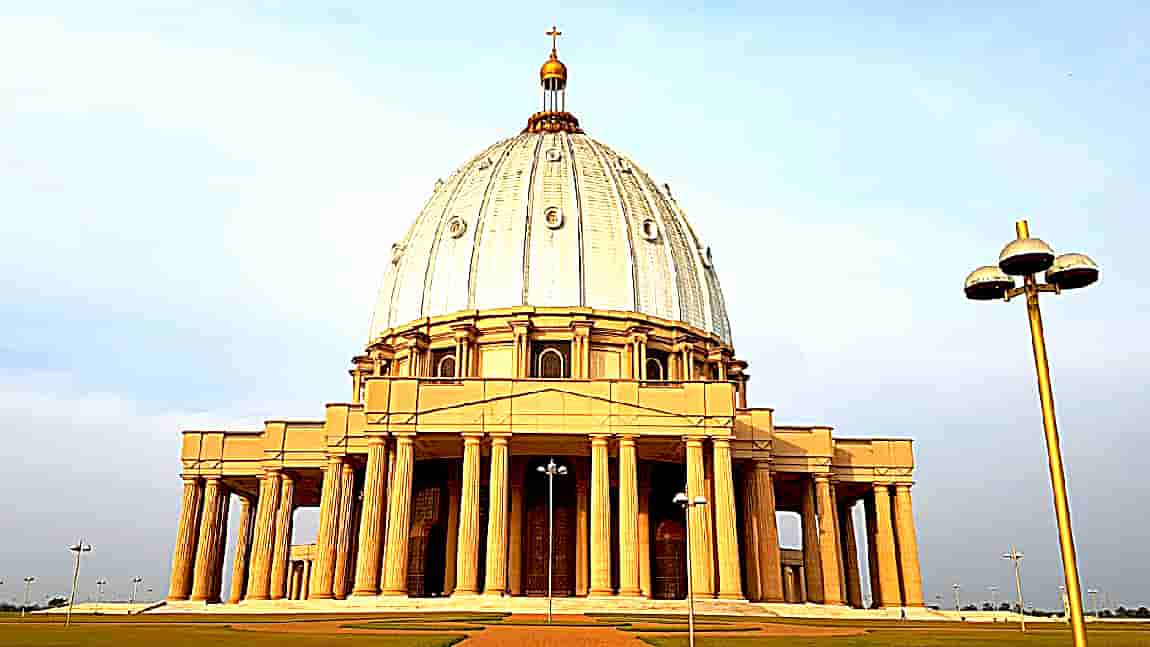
{"left": 169, "top": 433, "right": 922, "bottom": 607}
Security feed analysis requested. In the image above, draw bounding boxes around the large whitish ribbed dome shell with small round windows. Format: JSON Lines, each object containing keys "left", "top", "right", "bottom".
{"left": 370, "top": 132, "right": 730, "bottom": 342}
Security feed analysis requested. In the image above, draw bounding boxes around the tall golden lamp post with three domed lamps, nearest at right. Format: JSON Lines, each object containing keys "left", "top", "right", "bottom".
{"left": 965, "top": 221, "right": 1098, "bottom": 647}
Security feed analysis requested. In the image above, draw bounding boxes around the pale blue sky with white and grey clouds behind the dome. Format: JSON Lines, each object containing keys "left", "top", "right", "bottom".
{"left": 0, "top": 0, "right": 1150, "bottom": 608}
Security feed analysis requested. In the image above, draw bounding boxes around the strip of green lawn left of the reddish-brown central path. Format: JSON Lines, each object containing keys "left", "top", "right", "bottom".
{"left": 0, "top": 623, "right": 466, "bottom": 647}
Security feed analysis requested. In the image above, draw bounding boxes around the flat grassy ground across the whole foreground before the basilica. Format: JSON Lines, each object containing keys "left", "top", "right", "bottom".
{"left": 0, "top": 613, "right": 1150, "bottom": 647}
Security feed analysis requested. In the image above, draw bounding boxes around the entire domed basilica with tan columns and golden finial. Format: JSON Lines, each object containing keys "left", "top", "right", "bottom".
{"left": 168, "top": 36, "right": 922, "bottom": 607}
